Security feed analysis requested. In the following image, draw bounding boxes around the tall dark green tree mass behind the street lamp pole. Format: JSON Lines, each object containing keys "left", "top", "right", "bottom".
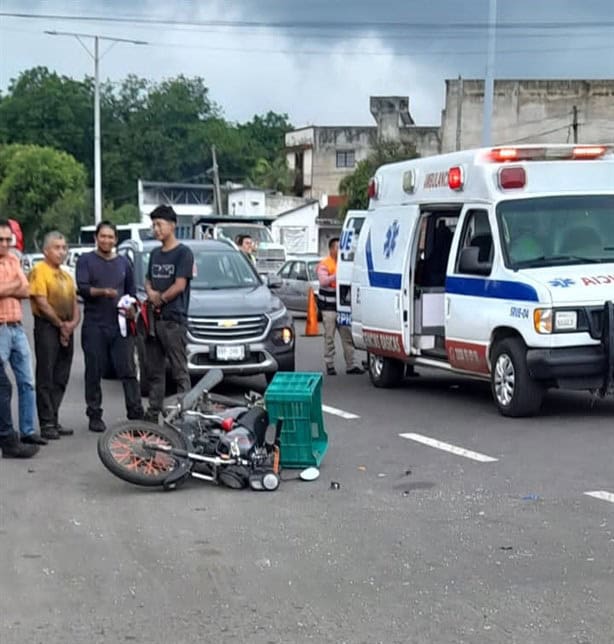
{"left": 0, "top": 67, "right": 292, "bottom": 216}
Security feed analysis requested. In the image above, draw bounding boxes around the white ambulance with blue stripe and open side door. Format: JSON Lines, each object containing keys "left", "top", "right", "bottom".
{"left": 351, "top": 145, "right": 614, "bottom": 417}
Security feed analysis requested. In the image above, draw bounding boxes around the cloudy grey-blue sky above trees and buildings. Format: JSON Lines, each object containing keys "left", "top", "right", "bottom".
{"left": 0, "top": 0, "right": 614, "bottom": 126}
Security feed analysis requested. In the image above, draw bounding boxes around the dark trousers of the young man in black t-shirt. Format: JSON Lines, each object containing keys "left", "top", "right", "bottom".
{"left": 145, "top": 320, "right": 191, "bottom": 411}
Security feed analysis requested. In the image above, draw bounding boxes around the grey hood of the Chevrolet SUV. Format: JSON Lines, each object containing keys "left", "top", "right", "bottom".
{"left": 188, "top": 284, "right": 283, "bottom": 317}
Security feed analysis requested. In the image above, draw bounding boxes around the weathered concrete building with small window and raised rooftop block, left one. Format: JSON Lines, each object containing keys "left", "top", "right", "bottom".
{"left": 285, "top": 96, "right": 440, "bottom": 199}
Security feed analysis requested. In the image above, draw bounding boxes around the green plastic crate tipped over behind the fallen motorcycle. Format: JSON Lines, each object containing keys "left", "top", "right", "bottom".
{"left": 264, "top": 372, "right": 328, "bottom": 469}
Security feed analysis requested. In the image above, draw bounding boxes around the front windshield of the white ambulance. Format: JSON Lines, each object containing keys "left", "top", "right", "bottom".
{"left": 497, "top": 195, "right": 614, "bottom": 268}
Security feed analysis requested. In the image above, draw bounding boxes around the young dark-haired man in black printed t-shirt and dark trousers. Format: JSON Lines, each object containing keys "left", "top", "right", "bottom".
{"left": 145, "top": 206, "right": 194, "bottom": 422}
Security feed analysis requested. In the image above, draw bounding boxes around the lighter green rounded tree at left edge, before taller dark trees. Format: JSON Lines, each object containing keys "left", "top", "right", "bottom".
{"left": 0, "top": 144, "right": 85, "bottom": 246}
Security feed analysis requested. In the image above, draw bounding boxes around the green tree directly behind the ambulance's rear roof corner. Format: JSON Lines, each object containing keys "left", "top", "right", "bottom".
{"left": 339, "top": 141, "right": 419, "bottom": 218}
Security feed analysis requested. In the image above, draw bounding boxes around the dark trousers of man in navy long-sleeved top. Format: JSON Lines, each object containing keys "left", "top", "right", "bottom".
{"left": 81, "top": 321, "right": 143, "bottom": 419}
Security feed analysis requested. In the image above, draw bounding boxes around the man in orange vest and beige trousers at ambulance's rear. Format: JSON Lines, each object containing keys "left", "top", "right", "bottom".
{"left": 317, "top": 237, "right": 364, "bottom": 376}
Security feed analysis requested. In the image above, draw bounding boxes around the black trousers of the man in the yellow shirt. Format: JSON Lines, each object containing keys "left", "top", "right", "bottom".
{"left": 34, "top": 315, "right": 73, "bottom": 429}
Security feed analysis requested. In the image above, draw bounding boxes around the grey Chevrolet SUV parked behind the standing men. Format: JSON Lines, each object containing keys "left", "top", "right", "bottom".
{"left": 118, "top": 240, "right": 295, "bottom": 393}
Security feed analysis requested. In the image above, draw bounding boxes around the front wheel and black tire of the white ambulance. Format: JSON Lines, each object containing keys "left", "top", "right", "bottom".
{"left": 490, "top": 337, "right": 544, "bottom": 418}
